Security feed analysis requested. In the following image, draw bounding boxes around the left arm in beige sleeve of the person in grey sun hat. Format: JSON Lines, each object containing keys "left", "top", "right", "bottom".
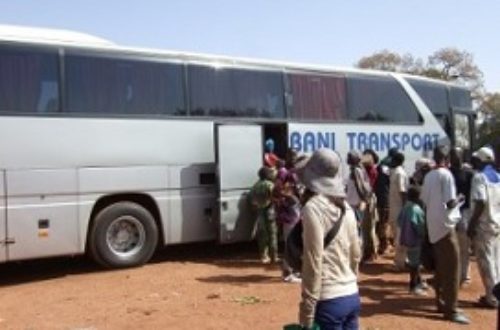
{"left": 299, "top": 205, "right": 324, "bottom": 327}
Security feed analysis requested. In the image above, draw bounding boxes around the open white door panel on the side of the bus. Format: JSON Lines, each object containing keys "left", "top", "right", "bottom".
{"left": 215, "top": 125, "right": 263, "bottom": 243}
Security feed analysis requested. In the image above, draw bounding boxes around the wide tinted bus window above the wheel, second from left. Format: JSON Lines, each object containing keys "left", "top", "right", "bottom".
{"left": 65, "top": 55, "right": 186, "bottom": 115}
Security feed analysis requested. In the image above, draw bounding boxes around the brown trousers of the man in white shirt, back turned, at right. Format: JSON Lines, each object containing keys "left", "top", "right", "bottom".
{"left": 432, "top": 230, "right": 460, "bottom": 317}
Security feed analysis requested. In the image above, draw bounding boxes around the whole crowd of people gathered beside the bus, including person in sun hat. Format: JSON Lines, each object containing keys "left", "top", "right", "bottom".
{"left": 250, "top": 140, "right": 500, "bottom": 329}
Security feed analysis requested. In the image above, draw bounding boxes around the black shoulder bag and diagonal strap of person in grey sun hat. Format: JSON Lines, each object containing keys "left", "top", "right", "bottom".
{"left": 285, "top": 211, "right": 345, "bottom": 272}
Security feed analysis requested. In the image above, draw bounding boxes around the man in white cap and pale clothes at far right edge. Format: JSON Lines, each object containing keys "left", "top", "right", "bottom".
{"left": 468, "top": 147, "right": 500, "bottom": 308}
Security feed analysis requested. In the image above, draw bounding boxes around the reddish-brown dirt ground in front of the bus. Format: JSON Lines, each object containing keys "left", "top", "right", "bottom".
{"left": 0, "top": 244, "right": 496, "bottom": 330}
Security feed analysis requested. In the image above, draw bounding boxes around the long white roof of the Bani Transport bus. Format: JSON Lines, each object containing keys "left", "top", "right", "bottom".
{"left": 0, "top": 25, "right": 464, "bottom": 88}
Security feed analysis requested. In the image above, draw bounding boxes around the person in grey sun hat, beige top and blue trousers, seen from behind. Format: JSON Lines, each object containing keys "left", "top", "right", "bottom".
{"left": 297, "top": 149, "right": 361, "bottom": 329}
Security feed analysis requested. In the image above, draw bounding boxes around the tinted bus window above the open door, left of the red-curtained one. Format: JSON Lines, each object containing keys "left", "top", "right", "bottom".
{"left": 188, "top": 65, "right": 285, "bottom": 118}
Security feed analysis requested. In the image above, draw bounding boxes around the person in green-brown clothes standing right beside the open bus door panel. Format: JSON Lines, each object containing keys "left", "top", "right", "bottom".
{"left": 250, "top": 167, "right": 278, "bottom": 264}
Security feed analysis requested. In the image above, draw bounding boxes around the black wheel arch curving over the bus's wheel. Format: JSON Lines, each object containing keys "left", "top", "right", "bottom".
{"left": 85, "top": 193, "right": 165, "bottom": 252}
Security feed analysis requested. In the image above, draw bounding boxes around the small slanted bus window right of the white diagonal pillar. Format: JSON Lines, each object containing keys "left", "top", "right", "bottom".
{"left": 408, "top": 79, "right": 450, "bottom": 115}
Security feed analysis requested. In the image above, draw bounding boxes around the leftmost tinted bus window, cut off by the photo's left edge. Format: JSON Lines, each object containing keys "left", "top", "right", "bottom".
{"left": 0, "top": 48, "right": 59, "bottom": 113}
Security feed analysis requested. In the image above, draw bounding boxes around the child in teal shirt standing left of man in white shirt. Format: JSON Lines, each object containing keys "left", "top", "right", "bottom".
{"left": 398, "top": 186, "right": 426, "bottom": 296}
